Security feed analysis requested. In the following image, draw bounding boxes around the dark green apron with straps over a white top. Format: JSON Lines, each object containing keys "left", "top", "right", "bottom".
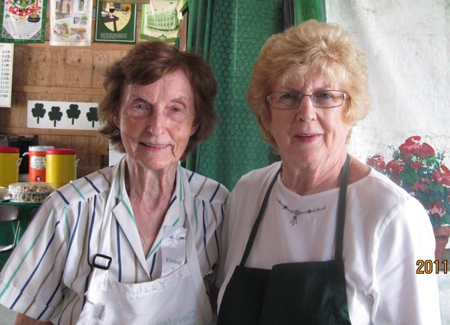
{"left": 217, "top": 155, "right": 351, "bottom": 325}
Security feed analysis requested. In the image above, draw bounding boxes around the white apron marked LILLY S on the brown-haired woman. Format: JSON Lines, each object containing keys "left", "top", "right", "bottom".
{"left": 77, "top": 167, "right": 212, "bottom": 325}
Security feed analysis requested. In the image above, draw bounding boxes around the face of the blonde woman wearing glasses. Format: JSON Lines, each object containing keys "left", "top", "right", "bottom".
{"left": 264, "top": 74, "right": 351, "bottom": 166}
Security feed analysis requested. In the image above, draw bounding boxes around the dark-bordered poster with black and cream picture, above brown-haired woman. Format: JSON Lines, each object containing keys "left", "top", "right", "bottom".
{"left": 95, "top": 0, "right": 137, "bottom": 43}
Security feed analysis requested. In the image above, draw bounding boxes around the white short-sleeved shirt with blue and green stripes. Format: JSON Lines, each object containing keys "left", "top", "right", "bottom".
{"left": 0, "top": 159, "right": 229, "bottom": 324}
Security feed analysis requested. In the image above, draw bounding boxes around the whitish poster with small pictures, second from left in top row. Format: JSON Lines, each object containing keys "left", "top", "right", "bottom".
{"left": 50, "top": 0, "right": 92, "bottom": 46}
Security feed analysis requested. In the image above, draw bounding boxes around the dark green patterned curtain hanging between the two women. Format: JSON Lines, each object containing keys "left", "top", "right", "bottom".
{"left": 186, "top": 0, "right": 324, "bottom": 190}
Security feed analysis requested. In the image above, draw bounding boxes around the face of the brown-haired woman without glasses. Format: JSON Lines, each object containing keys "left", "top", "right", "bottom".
{"left": 116, "top": 71, "right": 197, "bottom": 170}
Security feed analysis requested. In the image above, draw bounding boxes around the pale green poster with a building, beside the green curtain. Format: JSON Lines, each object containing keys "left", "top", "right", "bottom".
{"left": 141, "top": 0, "right": 187, "bottom": 44}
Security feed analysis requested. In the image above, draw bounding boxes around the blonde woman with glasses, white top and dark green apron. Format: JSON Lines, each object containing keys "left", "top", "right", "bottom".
{"left": 218, "top": 21, "right": 440, "bottom": 325}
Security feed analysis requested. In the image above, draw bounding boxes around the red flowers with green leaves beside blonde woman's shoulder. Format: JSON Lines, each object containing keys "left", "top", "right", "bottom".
{"left": 367, "top": 136, "right": 450, "bottom": 230}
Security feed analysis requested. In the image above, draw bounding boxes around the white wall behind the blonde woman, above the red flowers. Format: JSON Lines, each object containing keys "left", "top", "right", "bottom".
{"left": 325, "top": 0, "right": 450, "bottom": 166}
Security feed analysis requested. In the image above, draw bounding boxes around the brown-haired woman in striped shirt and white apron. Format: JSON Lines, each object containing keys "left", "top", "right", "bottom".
{"left": 0, "top": 42, "right": 228, "bottom": 325}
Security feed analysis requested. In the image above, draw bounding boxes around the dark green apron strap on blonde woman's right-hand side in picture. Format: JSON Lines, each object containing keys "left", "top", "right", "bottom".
{"left": 334, "top": 154, "right": 350, "bottom": 261}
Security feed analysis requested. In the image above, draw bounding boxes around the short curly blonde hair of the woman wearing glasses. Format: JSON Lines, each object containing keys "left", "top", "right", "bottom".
{"left": 247, "top": 20, "right": 371, "bottom": 149}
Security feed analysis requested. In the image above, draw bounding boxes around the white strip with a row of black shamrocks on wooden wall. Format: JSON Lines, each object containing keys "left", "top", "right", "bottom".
{"left": 27, "top": 100, "right": 100, "bottom": 131}
